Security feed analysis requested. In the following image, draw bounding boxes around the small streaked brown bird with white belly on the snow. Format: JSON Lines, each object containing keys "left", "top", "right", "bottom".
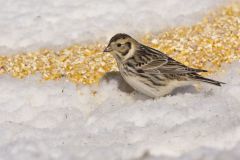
{"left": 103, "top": 33, "right": 225, "bottom": 98}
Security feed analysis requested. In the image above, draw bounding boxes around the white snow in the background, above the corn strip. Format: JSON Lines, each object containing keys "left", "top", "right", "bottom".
{"left": 0, "top": 0, "right": 226, "bottom": 54}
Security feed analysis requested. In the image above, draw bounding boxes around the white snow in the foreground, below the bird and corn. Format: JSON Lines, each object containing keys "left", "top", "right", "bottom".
{"left": 0, "top": 63, "right": 240, "bottom": 160}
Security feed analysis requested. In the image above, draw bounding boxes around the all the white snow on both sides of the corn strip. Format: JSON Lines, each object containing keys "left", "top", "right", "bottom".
{"left": 0, "top": 0, "right": 240, "bottom": 160}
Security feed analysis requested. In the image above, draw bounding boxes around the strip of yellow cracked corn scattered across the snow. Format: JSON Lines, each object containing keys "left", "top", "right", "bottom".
{"left": 0, "top": 3, "right": 240, "bottom": 84}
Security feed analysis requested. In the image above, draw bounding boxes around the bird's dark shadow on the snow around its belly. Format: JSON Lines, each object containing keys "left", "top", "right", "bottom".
{"left": 100, "top": 71, "right": 197, "bottom": 99}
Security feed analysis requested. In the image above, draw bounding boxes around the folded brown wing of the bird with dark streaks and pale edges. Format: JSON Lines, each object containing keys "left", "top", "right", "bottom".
{"left": 137, "top": 46, "right": 207, "bottom": 74}
